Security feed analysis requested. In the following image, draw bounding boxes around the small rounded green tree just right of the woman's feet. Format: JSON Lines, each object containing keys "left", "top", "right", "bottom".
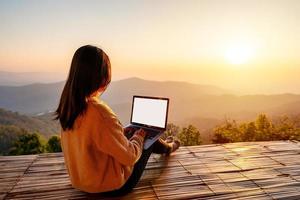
{"left": 177, "top": 125, "right": 202, "bottom": 146}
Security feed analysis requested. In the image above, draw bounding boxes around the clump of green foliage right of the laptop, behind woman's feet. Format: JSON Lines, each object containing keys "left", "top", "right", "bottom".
{"left": 162, "top": 124, "right": 202, "bottom": 146}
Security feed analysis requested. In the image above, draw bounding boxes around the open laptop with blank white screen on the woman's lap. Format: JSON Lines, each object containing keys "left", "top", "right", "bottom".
{"left": 126, "top": 96, "right": 169, "bottom": 149}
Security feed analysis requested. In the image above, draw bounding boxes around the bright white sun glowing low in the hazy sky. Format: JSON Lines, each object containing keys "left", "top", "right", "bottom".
{"left": 225, "top": 44, "right": 254, "bottom": 65}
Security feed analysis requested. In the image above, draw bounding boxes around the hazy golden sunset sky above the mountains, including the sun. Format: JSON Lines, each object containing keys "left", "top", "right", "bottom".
{"left": 0, "top": 0, "right": 300, "bottom": 93}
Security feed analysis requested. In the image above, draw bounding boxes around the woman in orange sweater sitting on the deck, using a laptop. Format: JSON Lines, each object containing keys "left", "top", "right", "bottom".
{"left": 56, "top": 45, "right": 180, "bottom": 195}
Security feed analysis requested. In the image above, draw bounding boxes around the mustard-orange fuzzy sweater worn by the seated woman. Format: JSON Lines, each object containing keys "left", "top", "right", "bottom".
{"left": 61, "top": 98, "right": 144, "bottom": 193}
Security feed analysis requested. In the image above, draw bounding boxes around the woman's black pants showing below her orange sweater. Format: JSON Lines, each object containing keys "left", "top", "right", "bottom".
{"left": 103, "top": 132, "right": 171, "bottom": 196}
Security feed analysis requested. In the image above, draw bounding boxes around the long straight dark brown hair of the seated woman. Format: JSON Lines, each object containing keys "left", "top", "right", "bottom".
{"left": 55, "top": 45, "right": 111, "bottom": 130}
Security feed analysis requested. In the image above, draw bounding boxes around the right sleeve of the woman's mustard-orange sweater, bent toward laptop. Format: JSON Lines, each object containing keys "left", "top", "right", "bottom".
{"left": 95, "top": 109, "right": 144, "bottom": 166}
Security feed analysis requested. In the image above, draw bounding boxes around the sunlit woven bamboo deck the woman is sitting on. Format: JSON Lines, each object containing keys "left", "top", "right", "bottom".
{"left": 0, "top": 141, "right": 300, "bottom": 200}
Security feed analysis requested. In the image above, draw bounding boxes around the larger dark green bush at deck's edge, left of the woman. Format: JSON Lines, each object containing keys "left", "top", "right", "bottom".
{"left": 10, "top": 133, "right": 45, "bottom": 155}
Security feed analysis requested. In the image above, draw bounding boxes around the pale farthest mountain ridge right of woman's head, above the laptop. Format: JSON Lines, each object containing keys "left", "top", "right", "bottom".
{"left": 103, "top": 77, "right": 232, "bottom": 104}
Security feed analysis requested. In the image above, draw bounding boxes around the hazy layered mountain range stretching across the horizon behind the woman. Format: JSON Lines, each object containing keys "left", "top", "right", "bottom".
{"left": 0, "top": 78, "right": 300, "bottom": 136}
